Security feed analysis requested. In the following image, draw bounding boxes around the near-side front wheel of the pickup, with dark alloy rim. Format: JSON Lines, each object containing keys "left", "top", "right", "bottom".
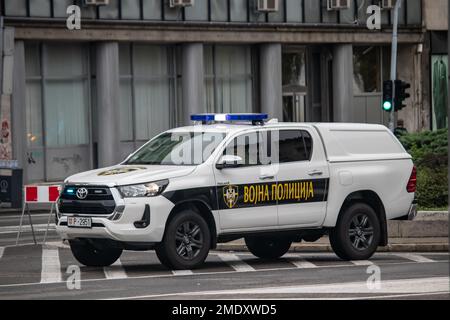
{"left": 155, "top": 210, "right": 211, "bottom": 270}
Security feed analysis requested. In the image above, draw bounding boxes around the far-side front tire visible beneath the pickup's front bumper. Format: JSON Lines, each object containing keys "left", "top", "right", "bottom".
{"left": 69, "top": 241, "right": 123, "bottom": 267}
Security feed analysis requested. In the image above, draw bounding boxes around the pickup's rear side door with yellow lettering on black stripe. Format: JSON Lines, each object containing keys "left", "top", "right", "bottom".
{"left": 276, "top": 128, "right": 330, "bottom": 228}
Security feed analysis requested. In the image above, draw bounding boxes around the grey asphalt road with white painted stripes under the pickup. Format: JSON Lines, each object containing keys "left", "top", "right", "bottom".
{"left": 0, "top": 243, "right": 450, "bottom": 300}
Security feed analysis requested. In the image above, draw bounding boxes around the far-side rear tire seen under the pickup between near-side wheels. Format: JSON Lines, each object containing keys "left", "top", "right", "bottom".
{"left": 245, "top": 236, "right": 292, "bottom": 260}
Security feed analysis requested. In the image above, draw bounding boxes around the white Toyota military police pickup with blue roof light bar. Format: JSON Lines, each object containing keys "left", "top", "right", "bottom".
{"left": 57, "top": 114, "right": 416, "bottom": 269}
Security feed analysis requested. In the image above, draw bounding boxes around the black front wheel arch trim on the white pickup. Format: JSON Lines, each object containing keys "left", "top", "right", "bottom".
{"left": 164, "top": 199, "right": 217, "bottom": 249}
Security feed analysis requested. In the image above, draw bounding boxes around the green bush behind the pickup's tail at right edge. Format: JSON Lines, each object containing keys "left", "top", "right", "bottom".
{"left": 400, "top": 129, "right": 448, "bottom": 208}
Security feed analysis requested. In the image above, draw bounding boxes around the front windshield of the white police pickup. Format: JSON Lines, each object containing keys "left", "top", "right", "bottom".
{"left": 125, "top": 132, "right": 225, "bottom": 166}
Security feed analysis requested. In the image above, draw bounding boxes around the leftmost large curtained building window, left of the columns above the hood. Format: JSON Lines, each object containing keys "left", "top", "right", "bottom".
{"left": 25, "top": 44, "right": 89, "bottom": 147}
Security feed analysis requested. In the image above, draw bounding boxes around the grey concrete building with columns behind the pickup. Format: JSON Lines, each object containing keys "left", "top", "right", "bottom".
{"left": 0, "top": 0, "right": 447, "bottom": 182}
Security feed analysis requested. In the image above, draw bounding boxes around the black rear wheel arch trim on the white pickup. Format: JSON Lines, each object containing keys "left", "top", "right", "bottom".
{"left": 338, "top": 190, "right": 388, "bottom": 246}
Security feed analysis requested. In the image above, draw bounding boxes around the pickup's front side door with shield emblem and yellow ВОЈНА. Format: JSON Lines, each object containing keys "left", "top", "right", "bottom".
{"left": 214, "top": 131, "right": 278, "bottom": 232}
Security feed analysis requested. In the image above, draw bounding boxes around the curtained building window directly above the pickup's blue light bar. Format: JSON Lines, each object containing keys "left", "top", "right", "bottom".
{"left": 204, "top": 46, "right": 253, "bottom": 112}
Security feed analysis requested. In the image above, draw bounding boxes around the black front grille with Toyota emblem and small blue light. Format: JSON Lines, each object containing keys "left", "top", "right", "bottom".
{"left": 58, "top": 186, "right": 116, "bottom": 215}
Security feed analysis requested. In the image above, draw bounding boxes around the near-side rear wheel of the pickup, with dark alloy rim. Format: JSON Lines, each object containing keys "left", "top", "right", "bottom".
{"left": 330, "top": 203, "right": 381, "bottom": 261}
